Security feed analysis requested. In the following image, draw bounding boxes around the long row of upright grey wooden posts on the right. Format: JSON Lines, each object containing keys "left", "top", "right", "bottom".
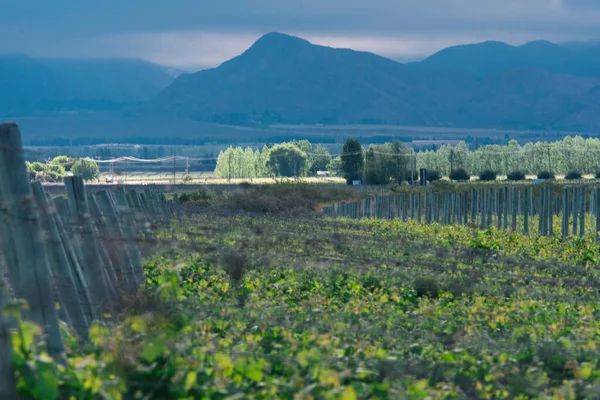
{"left": 323, "top": 182, "right": 600, "bottom": 239}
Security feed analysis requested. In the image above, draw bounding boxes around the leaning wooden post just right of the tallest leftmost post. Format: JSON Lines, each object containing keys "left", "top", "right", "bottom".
{"left": 31, "top": 181, "right": 91, "bottom": 339}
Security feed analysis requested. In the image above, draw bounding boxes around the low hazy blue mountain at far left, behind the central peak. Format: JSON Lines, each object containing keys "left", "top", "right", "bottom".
{"left": 0, "top": 54, "right": 174, "bottom": 116}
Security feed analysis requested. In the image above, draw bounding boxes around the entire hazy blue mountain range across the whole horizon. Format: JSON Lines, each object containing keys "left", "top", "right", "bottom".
{"left": 5, "top": 33, "right": 600, "bottom": 132}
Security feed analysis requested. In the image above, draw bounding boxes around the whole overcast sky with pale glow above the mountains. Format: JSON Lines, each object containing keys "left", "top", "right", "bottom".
{"left": 0, "top": 0, "right": 600, "bottom": 70}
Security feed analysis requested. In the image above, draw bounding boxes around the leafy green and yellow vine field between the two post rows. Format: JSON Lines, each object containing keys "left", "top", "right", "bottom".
{"left": 9, "top": 185, "right": 600, "bottom": 400}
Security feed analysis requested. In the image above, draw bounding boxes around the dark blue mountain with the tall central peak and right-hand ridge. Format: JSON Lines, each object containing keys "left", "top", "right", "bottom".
{"left": 146, "top": 33, "right": 600, "bottom": 130}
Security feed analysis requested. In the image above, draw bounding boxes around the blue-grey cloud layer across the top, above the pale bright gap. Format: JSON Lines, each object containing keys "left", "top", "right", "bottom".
{"left": 0, "top": 0, "right": 600, "bottom": 65}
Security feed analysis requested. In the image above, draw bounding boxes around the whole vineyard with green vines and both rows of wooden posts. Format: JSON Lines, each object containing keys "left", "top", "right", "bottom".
{"left": 0, "top": 121, "right": 600, "bottom": 400}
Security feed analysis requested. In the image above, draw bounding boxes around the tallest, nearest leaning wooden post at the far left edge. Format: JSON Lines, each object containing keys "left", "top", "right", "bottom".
{"left": 0, "top": 124, "right": 64, "bottom": 360}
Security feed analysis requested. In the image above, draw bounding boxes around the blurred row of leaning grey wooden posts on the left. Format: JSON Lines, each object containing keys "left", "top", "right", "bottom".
{"left": 0, "top": 124, "right": 182, "bottom": 399}
